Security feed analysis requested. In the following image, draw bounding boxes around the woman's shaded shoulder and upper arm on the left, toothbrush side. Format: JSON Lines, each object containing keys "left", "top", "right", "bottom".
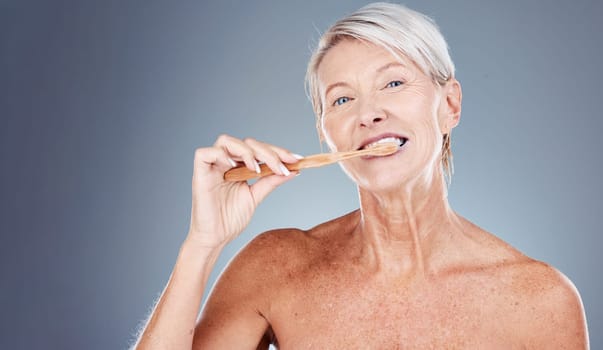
{"left": 195, "top": 221, "right": 330, "bottom": 349}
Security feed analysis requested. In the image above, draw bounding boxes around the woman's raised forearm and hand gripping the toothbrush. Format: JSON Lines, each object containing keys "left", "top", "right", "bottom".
{"left": 135, "top": 135, "right": 297, "bottom": 349}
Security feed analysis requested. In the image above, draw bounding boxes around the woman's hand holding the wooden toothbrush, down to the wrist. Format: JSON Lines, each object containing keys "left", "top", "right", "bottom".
{"left": 187, "top": 135, "right": 298, "bottom": 249}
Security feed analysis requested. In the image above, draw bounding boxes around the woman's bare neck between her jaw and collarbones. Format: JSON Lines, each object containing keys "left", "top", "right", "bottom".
{"left": 356, "top": 172, "right": 458, "bottom": 276}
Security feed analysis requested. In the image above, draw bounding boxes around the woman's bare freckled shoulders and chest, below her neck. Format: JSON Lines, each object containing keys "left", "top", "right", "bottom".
{"left": 201, "top": 211, "right": 586, "bottom": 349}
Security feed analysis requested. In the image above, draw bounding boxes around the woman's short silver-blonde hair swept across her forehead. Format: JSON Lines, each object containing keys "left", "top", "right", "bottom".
{"left": 306, "top": 2, "right": 454, "bottom": 180}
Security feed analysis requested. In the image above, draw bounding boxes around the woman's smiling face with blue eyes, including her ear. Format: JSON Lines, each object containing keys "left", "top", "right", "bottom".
{"left": 318, "top": 39, "right": 460, "bottom": 190}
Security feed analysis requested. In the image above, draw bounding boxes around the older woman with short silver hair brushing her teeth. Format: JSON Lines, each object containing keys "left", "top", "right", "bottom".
{"left": 137, "top": 3, "right": 588, "bottom": 349}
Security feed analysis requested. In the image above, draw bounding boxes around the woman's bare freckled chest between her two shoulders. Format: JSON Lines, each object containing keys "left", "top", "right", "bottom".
{"left": 270, "top": 256, "right": 528, "bottom": 349}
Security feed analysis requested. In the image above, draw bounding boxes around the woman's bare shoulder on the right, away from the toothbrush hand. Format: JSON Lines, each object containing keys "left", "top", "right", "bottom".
{"left": 455, "top": 222, "right": 588, "bottom": 349}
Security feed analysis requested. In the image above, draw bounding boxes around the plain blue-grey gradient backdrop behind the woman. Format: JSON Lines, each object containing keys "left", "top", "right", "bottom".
{"left": 0, "top": 0, "right": 603, "bottom": 349}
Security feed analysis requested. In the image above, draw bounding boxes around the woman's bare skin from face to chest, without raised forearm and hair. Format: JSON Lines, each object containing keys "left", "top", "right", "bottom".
{"left": 193, "top": 40, "right": 588, "bottom": 349}
